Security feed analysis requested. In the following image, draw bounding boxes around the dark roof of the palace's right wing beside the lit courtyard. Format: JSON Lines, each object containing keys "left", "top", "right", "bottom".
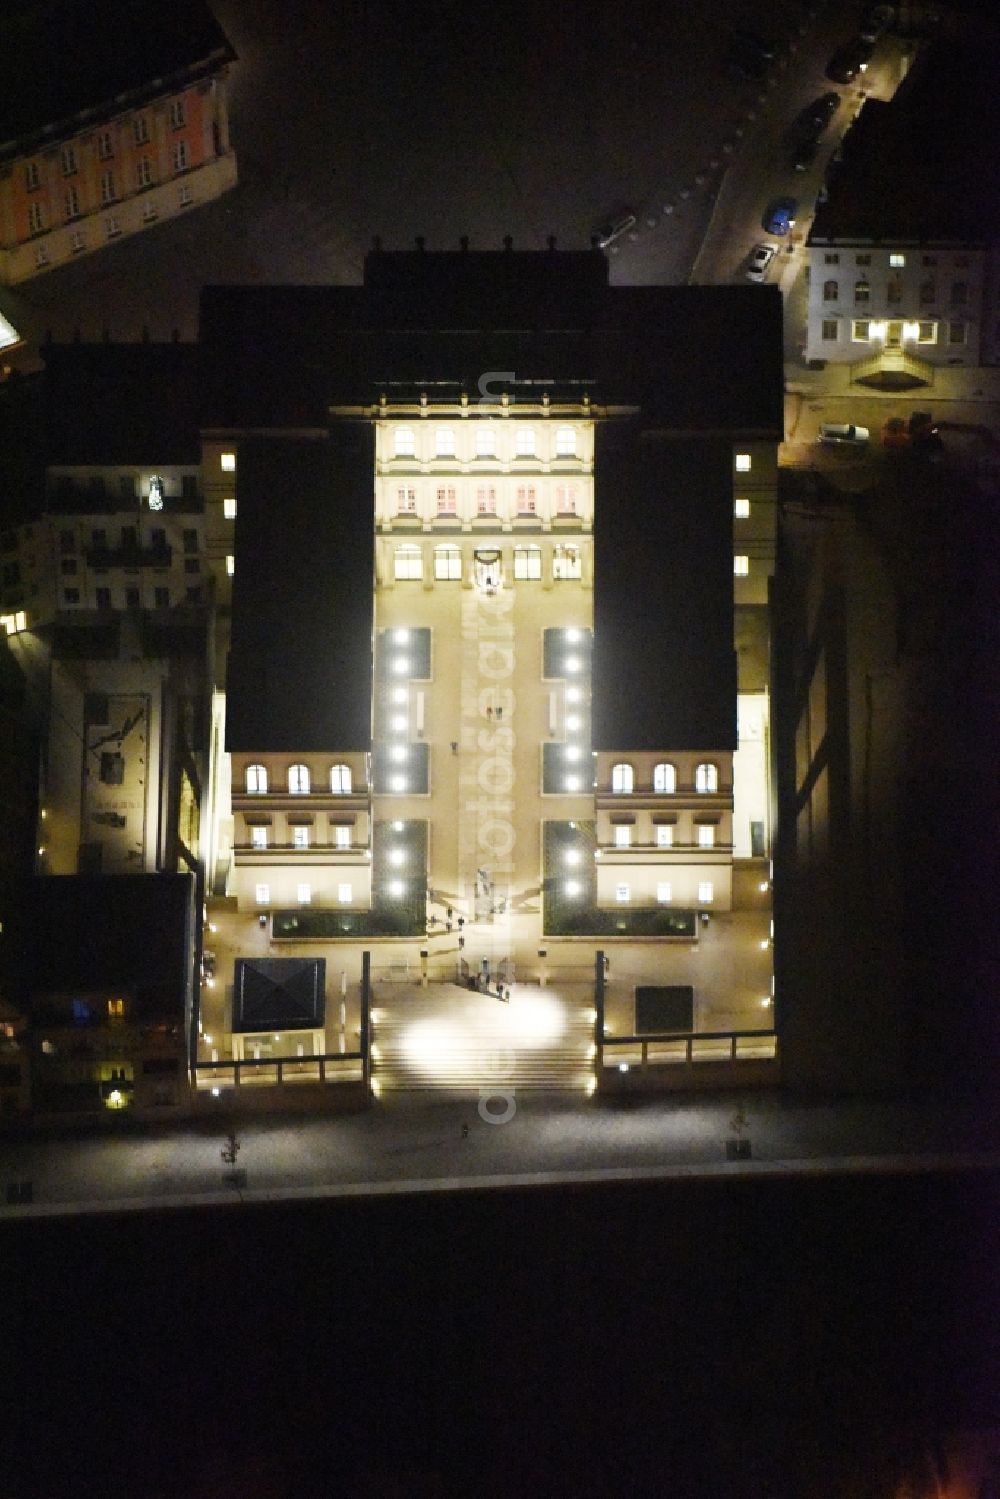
{"left": 592, "top": 423, "right": 736, "bottom": 751}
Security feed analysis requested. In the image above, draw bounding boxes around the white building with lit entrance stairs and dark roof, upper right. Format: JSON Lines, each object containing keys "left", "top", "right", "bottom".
{"left": 805, "top": 29, "right": 1000, "bottom": 374}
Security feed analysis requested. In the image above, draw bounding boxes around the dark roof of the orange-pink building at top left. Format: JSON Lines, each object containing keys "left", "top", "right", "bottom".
{"left": 0, "top": 0, "right": 235, "bottom": 151}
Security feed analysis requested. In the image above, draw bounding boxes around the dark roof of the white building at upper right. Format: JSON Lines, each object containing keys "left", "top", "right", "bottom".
{"left": 810, "top": 30, "right": 1000, "bottom": 244}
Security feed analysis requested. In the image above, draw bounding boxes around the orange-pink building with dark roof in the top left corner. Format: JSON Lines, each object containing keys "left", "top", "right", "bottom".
{"left": 0, "top": 0, "right": 237, "bottom": 283}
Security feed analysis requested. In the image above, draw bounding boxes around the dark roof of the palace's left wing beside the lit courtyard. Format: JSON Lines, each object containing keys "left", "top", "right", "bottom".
{"left": 226, "top": 437, "right": 375, "bottom": 752}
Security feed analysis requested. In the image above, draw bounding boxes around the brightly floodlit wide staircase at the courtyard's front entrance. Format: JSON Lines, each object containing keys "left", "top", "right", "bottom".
{"left": 372, "top": 983, "right": 594, "bottom": 1093}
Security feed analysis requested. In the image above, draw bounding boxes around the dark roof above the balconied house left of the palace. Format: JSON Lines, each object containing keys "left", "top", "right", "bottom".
{"left": 42, "top": 343, "right": 201, "bottom": 465}
